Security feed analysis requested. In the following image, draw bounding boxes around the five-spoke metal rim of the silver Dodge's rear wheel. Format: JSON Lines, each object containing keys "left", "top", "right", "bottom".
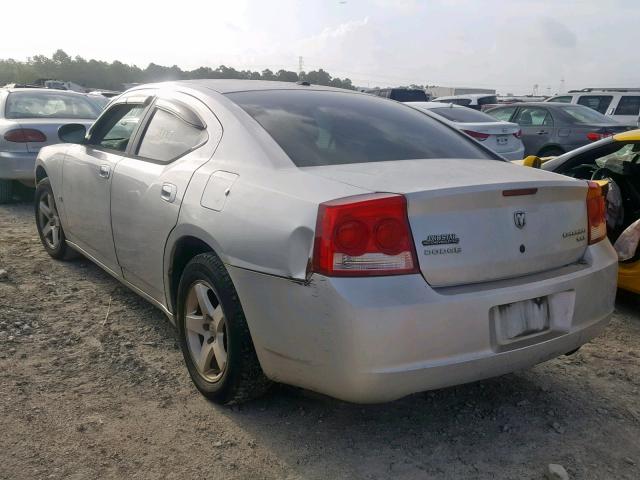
{"left": 184, "top": 281, "right": 227, "bottom": 382}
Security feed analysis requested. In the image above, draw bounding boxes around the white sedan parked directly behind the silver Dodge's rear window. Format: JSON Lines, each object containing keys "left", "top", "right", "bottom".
{"left": 407, "top": 102, "right": 524, "bottom": 160}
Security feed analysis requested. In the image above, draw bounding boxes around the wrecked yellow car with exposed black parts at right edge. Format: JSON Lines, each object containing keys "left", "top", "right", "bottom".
{"left": 515, "top": 130, "right": 640, "bottom": 294}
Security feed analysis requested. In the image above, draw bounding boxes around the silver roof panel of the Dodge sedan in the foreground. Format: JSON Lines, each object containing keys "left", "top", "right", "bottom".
{"left": 128, "top": 79, "right": 350, "bottom": 95}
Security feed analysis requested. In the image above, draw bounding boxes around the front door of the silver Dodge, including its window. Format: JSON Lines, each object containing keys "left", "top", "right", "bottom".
{"left": 62, "top": 103, "right": 145, "bottom": 274}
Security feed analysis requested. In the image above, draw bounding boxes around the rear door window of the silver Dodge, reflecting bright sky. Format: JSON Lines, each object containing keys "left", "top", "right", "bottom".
{"left": 137, "top": 109, "right": 206, "bottom": 162}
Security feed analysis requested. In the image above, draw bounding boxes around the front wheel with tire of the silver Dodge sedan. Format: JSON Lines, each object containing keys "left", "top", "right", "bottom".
{"left": 35, "top": 178, "right": 68, "bottom": 260}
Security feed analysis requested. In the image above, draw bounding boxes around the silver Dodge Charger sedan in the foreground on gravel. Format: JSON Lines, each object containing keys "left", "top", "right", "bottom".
{"left": 35, "top": 80, "right": 617, "bottom": 403}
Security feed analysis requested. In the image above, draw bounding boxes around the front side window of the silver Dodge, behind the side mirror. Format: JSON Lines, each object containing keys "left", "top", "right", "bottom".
{"left": 89, "top": 103, "right": 145, "bottom": 152}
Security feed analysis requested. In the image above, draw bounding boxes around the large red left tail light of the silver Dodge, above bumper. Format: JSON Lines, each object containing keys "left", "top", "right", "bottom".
{"left": 313, "top": 193, "right": 418, "bottom": 277}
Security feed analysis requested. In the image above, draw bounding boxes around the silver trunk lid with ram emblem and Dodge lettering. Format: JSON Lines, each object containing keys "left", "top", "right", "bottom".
{"left": 304, "top": 159, "right": 587, "bottom": 287}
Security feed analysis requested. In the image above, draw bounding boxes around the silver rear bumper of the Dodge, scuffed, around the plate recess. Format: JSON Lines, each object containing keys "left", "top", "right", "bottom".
{"left": 228, "top": 241, "right": 617, "bottom": 403}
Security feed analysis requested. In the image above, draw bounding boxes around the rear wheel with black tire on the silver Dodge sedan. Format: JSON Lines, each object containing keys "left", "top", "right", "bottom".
{"left": 176, "top": 253, "right": 270, "bottom": 404}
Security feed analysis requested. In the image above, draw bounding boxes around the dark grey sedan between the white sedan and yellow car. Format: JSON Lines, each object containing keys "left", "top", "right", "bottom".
{"left": 485, "top": 102, "right": 628, "bottom": 157}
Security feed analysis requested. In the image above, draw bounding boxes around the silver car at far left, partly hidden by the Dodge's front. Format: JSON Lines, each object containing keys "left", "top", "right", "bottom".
{"left": 0, "top": 88, "right": 102, "bottom": 203}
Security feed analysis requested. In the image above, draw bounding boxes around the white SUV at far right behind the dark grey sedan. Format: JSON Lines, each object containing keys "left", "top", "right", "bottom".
{"left": 546, "top": 88, "right": 640, "bottom": 127}
